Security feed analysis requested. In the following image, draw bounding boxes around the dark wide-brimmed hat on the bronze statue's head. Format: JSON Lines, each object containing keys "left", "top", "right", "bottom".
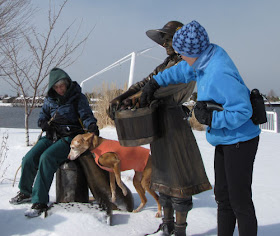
{"left": 146, "top": 21, "right": 183, "bottom": 46}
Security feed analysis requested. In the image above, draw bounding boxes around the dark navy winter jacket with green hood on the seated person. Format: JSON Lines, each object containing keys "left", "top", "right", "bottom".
{"left": 38, "top": 69, "right": 98, "bottom": 134}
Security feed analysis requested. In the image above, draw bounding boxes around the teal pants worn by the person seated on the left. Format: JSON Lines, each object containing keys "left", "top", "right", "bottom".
{"left": 19, "top": 137, "right": 72, "bottom": 203}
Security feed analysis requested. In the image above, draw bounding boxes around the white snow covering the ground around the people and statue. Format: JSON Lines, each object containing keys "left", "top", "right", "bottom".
{"left": 0, "top": 127, "right": 280, "bottom": 236}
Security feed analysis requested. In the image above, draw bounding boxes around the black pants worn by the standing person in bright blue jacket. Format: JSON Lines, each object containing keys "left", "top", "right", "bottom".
{"left": 214, "top": 137, "right": 259, "bottom": 236}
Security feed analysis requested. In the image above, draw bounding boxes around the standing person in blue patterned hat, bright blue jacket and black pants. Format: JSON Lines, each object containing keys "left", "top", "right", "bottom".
{"left": 141, "top": 21, "right": 260, "bottom": 236}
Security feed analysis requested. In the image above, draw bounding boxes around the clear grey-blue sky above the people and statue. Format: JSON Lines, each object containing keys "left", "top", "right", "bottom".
{"left": 0, "top": 0, "right": 280, "bottom": 96}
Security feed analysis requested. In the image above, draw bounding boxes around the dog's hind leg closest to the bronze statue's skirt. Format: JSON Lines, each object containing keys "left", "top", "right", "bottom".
{"left": 141, "top": 156, "right": 162, "bottom": 217}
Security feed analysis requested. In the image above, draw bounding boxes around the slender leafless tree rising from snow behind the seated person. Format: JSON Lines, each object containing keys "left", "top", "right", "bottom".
{"left": 0, "top": 0, "right": 91, "bottom": 146}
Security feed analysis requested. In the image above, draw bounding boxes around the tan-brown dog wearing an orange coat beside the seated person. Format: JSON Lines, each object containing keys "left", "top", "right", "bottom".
{"left": 68, "top": 133, "right": 161, "bottom": 217}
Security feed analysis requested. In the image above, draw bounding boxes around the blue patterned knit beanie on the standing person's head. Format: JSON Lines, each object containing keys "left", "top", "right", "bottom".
{"left": 172, "top": 20, "right": 210, "bottom": 57}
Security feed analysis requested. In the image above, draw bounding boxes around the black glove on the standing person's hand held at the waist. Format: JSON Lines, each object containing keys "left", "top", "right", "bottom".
{"left": 194, "top": 101, "right": 213, "bottom": 127}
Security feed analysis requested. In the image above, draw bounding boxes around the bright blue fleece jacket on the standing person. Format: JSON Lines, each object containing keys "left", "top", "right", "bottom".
{"left": 154, "top": 44, "right": 260, "bottom": 146}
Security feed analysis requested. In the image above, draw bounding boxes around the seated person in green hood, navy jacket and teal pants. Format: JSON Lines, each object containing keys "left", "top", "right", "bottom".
{"left": 10, "top": 68, "right": 99, "bottom": 217}
